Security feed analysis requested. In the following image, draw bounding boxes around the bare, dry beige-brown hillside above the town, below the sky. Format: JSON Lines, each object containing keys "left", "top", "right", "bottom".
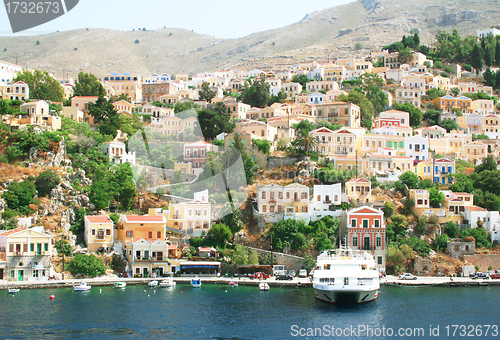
{"left": 0, "top": 0, "right": 500, "bottom": 75}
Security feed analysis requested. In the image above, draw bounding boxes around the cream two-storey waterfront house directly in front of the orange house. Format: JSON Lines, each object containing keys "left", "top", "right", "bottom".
{"left": 123, "top": 237, "right": 171, "bottom": 277}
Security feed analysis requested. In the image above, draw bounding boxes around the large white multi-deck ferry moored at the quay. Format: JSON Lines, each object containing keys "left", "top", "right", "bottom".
{"left": 313, "top": 248, "right": 380, "bottom": 303}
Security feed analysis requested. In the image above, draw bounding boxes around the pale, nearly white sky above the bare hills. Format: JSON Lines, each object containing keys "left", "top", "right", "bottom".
{"left": 0, "top": 0, "right": 353, "bottom": 39}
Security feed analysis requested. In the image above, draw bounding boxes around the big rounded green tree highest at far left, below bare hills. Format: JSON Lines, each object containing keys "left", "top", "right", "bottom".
{"left": 12, "top": 70, "right": 64, "bottom": 102}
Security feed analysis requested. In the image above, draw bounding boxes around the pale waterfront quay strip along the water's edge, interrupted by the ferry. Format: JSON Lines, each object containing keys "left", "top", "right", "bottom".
{"left": 0, "top": 275, "right": 500, "bottom": 290}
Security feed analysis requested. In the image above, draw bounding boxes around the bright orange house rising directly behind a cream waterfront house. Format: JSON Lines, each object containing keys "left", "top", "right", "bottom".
{"left": 118, "top": 215, "right": 166, "bottom": 244}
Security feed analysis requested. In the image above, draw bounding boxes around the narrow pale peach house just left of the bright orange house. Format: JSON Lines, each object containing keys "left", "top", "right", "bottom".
{"left": 84, "top": 215, "right": 115, "bottom": 253}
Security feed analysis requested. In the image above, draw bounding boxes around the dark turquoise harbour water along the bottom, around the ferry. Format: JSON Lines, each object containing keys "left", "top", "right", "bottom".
{"left": 0, "top": 284, "right": 500, "bottom": 340}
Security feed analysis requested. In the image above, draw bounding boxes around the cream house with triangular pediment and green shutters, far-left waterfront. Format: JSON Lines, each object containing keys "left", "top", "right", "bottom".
{"left": 0, "top": 227, "right": 52, "bottom": 281}
